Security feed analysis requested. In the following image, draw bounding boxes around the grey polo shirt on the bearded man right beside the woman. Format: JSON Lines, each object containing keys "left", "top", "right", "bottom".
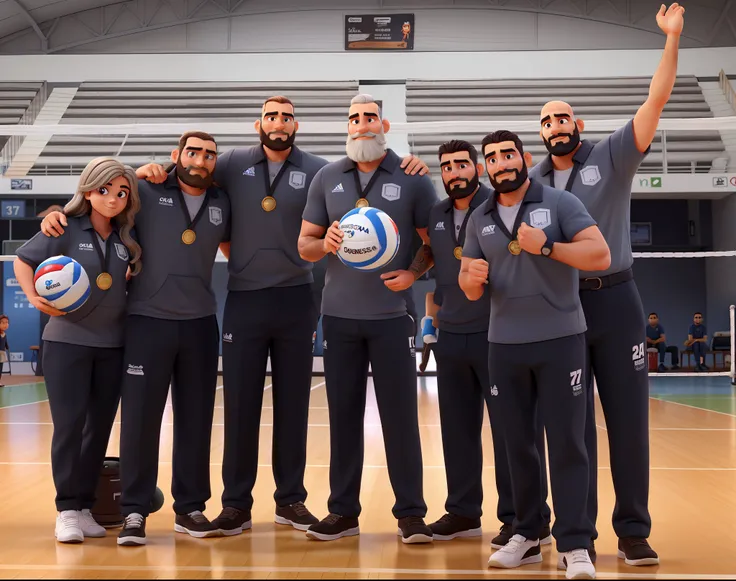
{"left": 128, "top": 171, "right": 230, "bottom": 321}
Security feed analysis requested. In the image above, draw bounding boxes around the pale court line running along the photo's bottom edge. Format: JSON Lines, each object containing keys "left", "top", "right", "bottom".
{"left": 0, "top": 560, "right": 734, "bottom": 580}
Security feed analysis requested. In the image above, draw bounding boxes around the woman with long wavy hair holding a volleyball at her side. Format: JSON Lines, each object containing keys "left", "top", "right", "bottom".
{"left": 14, "top": 157, "right": 141, "bottom": 543}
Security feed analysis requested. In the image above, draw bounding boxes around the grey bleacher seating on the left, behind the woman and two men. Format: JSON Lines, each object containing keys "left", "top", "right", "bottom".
{"left": 29, "top": 81, "right": 358, "bottom": 175}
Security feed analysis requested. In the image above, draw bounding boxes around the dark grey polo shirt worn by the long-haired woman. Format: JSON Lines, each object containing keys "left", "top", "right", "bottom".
{"left": 17, "top": 216, "right": 130, "bottom": 347}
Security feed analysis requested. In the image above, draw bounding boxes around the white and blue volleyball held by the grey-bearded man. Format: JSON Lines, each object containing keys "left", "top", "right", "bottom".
{"left": 337, "top": 208, "right": 399, "bottom": 271}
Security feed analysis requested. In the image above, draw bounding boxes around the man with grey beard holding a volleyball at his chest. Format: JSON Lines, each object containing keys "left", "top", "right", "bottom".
{"left": 299, "top": 95, "right": 437, "bottom": 543}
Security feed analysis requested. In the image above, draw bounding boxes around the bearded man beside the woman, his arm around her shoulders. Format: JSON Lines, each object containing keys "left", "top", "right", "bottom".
{"left": 42, "top": 131, "right": 230, "bottom": 546}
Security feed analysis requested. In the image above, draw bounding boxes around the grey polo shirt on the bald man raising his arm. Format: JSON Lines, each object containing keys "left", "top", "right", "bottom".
{"left": 529, "top": 120, "right": 649, "bottom": 278}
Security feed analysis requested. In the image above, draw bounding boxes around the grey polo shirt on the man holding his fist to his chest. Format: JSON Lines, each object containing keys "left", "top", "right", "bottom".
{"left": 463, "top": 180, "right": 595, "bottom": 344}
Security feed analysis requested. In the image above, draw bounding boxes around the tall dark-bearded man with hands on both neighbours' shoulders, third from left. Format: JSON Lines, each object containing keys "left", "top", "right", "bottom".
{"left": 135, "top": 96, "right": 426, "bottom": 536}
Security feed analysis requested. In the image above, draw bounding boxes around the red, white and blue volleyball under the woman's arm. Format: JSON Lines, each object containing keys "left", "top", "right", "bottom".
{"left": 33, "top": 256, "right": 91, "bottom": 313}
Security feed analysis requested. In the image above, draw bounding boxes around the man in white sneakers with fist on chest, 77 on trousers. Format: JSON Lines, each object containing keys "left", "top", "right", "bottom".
{"left": 459, "top": 131, "right": 610, "bottom": 579}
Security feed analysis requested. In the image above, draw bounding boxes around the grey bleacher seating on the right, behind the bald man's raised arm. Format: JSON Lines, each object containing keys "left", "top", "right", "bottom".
{"left": 406, "top": 77, "right": 725, "bottom": 173}
